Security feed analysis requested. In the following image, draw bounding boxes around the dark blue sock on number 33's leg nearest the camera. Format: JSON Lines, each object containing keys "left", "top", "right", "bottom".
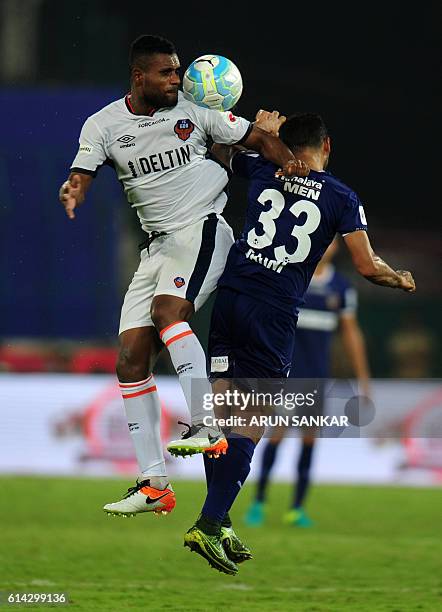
{"left": 201, "top": 436, "right": 255, "bottom": 523}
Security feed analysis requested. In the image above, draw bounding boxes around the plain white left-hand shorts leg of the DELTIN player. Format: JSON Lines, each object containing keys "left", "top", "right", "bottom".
{"left": 118, "top": 247, "right": 164, "bottom": 335}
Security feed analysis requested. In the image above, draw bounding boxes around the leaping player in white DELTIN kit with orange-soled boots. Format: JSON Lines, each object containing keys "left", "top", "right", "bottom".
{"left": 60, "top": 35, "right": 309, "bottom": 516}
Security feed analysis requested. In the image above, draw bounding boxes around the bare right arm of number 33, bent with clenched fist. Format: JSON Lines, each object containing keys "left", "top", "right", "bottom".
{"left": 344, "top": 231, "right": 416, "bottom": 293}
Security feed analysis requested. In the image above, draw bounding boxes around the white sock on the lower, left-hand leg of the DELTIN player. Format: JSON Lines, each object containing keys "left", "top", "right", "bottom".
{"left": 120, "top": 376, "right": 167, "bottom": 480}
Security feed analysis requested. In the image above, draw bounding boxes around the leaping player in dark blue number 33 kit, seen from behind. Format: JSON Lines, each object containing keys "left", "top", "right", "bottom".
{"left": 184, "top": 113, "right": 415, "bottom": 574}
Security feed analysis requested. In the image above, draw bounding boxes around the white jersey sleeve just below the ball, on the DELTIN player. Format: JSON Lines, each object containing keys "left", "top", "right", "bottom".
{"left": 193, "top": 105, "right": 252, "bottom": 145}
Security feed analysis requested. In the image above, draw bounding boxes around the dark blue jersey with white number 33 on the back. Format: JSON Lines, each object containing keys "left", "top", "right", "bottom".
{"left": 218, "top": 151, "right": 367, "bottom": 314}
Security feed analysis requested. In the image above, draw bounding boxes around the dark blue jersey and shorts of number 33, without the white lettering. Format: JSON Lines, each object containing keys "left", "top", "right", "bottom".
{"left": 209, "top": 152, "right": 367, "bottom": 378}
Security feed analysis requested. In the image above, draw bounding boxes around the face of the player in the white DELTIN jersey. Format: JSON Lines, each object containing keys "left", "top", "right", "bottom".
{"left": 140, "top": 53, "right": 181, "bottom": 108}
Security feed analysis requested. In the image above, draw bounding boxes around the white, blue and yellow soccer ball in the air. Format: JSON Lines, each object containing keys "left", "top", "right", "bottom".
{"left": 183, "top": 55, "right": 242, "bottom": 111}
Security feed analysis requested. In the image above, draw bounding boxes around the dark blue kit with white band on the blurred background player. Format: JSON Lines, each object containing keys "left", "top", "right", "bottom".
{"left": 290, "top": 265, "right": 357, "bottom": 378}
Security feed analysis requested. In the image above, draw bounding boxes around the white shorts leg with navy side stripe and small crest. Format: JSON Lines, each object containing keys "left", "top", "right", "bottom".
{"left": 155, "top": 214, "right": 233, "bottom": 310}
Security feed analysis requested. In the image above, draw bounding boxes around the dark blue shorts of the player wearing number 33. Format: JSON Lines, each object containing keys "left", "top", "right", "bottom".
{"left": 209, "top": 287, "right": 297, "bottom": 378}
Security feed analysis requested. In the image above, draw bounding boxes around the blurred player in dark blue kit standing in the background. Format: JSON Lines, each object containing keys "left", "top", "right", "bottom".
{"left": 245, "top": 238, "right": 369, "bottom": 527}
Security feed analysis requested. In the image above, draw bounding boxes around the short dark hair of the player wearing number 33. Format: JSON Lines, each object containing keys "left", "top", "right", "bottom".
{"left": 279, "top": 113, "right": 328, "bottom": 151}
